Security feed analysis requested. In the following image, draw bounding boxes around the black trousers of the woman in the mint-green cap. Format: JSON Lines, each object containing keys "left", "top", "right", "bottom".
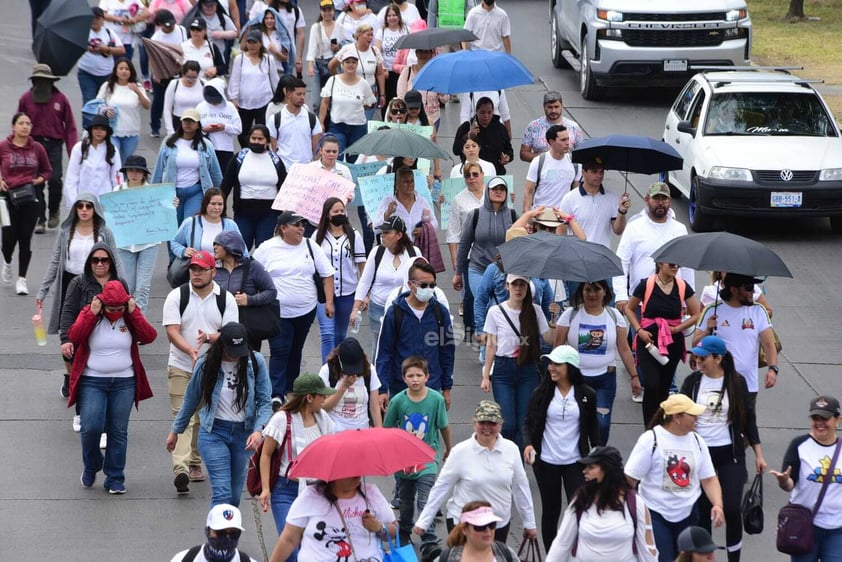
{"left": 532, "top": 458, "right": 585, "bottom": 552}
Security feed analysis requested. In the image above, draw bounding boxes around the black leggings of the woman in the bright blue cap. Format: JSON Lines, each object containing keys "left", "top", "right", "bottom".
{"left": 696, "top": 445, "right": 748, "bottom": 562}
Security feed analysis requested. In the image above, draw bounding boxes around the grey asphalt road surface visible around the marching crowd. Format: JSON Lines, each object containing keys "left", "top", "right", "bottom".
{"left": 0, "top": 0, "right": 842, "bottom": 562}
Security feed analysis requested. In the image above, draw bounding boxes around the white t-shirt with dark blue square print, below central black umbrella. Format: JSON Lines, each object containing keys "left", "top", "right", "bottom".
{"left": 556, "top": 304, "right": 628, "bottom": 377}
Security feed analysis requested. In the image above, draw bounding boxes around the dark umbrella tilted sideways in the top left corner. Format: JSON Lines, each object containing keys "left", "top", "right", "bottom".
{"left": 32, "top": 0, "right": 93, "bottom": 76}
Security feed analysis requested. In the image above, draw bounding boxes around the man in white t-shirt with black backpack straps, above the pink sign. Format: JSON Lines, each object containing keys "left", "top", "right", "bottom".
{"left": 266, "top": 77, "right": 322, "bottom": 170}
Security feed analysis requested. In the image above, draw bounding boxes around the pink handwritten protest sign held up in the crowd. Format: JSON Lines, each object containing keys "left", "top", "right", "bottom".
{"left": 272, "top": 164, "right": 354, "bottom": 224}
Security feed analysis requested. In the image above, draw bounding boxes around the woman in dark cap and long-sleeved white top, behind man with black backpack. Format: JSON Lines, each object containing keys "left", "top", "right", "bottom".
{"left": 228, "top": 29, "right": 279, "bottom": 147}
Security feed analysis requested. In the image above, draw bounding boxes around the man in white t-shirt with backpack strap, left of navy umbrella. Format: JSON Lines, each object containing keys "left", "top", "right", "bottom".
{"left": 523, "top": 125, "right": 576, "bottom": 213}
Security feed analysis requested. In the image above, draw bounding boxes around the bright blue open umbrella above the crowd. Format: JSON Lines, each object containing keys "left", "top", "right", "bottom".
{"left": 412, "top": 51, "right": 535, "bottom": 94}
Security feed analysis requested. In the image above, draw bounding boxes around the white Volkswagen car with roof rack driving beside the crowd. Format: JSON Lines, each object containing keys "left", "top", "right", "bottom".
{"left": 663, "top": 70, "right": 842, "bottom": 234}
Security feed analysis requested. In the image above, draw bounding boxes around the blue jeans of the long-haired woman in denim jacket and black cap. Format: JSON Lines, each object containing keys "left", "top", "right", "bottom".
{"left": 199, "top": 418, "right": 252, "bottom": 507}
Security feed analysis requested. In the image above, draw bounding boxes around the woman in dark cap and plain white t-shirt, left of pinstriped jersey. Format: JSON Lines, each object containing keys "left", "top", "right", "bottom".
{"left": 254, "top": 211, "right": 335, "bottom": 397}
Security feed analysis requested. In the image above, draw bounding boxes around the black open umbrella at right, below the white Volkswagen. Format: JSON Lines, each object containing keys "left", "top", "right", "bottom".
{"left": 652, "top": 232, "right": 792, "bottom": 277}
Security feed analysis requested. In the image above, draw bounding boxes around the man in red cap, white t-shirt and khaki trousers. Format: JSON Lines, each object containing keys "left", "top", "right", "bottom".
{"left": 162, "top": 252, "right": 240, "bottom": 495}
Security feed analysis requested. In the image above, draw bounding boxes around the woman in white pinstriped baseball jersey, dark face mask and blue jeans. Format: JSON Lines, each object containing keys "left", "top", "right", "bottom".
{"left": 313, "top": 197, "right": 366, "bottom": 362}
